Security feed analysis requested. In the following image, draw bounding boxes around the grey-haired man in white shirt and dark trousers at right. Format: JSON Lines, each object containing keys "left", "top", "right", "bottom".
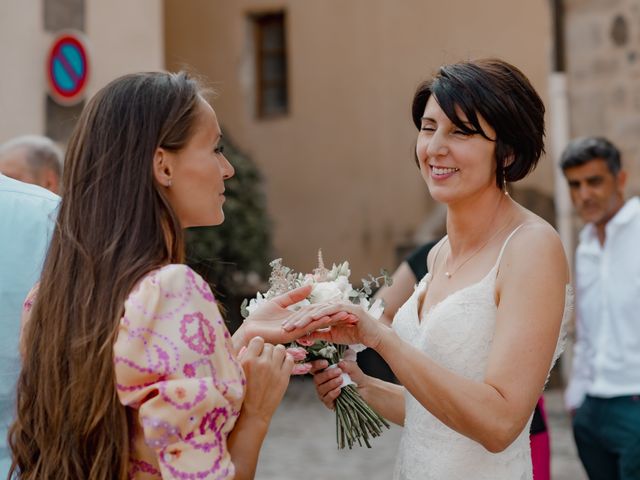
{"left": 560, "top": 137, "right": 640, "bottom": 480}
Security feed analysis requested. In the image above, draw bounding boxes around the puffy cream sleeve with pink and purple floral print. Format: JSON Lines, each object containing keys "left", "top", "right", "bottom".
{"left": 114, "top": 265, "right": 245, "bottom": 479}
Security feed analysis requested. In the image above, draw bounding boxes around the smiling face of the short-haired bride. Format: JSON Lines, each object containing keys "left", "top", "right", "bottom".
{"left": 416, "top": 95, "right": 497, "bottom": 204}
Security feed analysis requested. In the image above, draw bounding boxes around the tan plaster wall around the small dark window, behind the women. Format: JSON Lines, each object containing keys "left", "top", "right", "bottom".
{"left": 165, "top": 0, "right": 553, "bottom": 279}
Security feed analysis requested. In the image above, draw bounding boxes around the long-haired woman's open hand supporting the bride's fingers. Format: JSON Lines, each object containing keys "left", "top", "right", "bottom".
{"left": 233, "top": 285, "right": 348, "bottom": 351}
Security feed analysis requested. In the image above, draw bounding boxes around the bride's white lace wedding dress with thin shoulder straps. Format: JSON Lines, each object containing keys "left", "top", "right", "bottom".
{"left": 393, "top": 226, "right": 572, "bottom": 480}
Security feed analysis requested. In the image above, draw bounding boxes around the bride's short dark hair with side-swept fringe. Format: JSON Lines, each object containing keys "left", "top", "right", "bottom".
{"left": 411, "top": 58, "right": 545, "bottom": 188}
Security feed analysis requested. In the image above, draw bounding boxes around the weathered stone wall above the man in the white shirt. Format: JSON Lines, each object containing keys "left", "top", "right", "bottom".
{"left": 565, "top": 0, "right": 640, "bottom": 194}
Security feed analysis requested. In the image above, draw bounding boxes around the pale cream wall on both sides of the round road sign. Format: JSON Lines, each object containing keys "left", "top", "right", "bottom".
{"left": 0, "top": 0, "right": 164, "bottom": 142}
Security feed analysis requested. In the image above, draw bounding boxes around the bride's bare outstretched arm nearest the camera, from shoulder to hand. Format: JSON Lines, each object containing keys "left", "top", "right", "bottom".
{"left": 302, "top": 224, "right": 569, "bottom": 452}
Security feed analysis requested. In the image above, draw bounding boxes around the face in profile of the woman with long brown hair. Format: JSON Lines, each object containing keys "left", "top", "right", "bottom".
{"left": 167, "top": 100, "right": 234, "bottom": 228}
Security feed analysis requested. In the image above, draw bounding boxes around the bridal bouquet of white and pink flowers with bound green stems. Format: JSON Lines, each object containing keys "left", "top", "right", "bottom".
{"left": 242, "top": 251, "right": 391, "bottom": 449}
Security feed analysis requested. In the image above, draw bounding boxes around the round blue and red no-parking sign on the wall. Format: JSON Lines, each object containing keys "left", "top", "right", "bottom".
{"left": 47, "top": 32, "right": 89, "bottom": 105}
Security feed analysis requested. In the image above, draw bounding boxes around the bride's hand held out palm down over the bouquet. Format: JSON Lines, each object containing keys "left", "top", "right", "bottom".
{"left": 283, "top": 303, "right": 388, "bottom": 349}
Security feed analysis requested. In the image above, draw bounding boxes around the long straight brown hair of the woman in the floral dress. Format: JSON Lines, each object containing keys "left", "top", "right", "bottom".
{"left": 9, "top": 69, "right": 201, "bottom": 479}
